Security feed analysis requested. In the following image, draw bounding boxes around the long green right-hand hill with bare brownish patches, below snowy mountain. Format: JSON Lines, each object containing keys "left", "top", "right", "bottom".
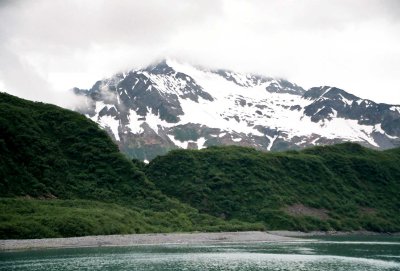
{"left": 146, "top": 143, "right": 400, "bottom": 231}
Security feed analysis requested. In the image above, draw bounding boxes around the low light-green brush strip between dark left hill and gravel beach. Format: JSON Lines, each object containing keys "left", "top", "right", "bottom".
{"left": 0, "top": 198, "right": 263, "bottom": 239}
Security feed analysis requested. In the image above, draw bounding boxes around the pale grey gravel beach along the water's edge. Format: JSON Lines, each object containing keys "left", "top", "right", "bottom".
{"left": 0, "top": 231, "right": 304, "bottom": 251}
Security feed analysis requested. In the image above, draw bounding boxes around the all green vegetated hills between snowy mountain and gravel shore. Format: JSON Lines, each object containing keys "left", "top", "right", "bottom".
{"left": 0, "top": 93, "right": 400, "bottom": 238}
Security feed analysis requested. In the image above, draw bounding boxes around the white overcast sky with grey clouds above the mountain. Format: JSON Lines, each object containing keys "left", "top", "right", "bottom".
{"left": 0, "top": 0, "right": 400, "bottom": 106}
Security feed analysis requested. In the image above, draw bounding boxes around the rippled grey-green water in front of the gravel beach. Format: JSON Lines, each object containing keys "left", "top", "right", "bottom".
{"left": 0, "top": 237, "right": 400, "bottom": 271}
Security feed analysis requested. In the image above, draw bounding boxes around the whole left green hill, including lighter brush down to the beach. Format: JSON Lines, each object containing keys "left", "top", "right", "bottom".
{"left": 0, "top": 93, "right": 262, "bottom": 238}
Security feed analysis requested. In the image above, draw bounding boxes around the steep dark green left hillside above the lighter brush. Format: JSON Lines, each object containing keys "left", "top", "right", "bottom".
{"left": 0, "top": 93, "right": 148, "bottom": 200}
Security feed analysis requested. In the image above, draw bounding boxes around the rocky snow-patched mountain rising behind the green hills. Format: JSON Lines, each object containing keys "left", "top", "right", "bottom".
{"left": 74, "top": 60, "right": 400, "bottom": 160}
